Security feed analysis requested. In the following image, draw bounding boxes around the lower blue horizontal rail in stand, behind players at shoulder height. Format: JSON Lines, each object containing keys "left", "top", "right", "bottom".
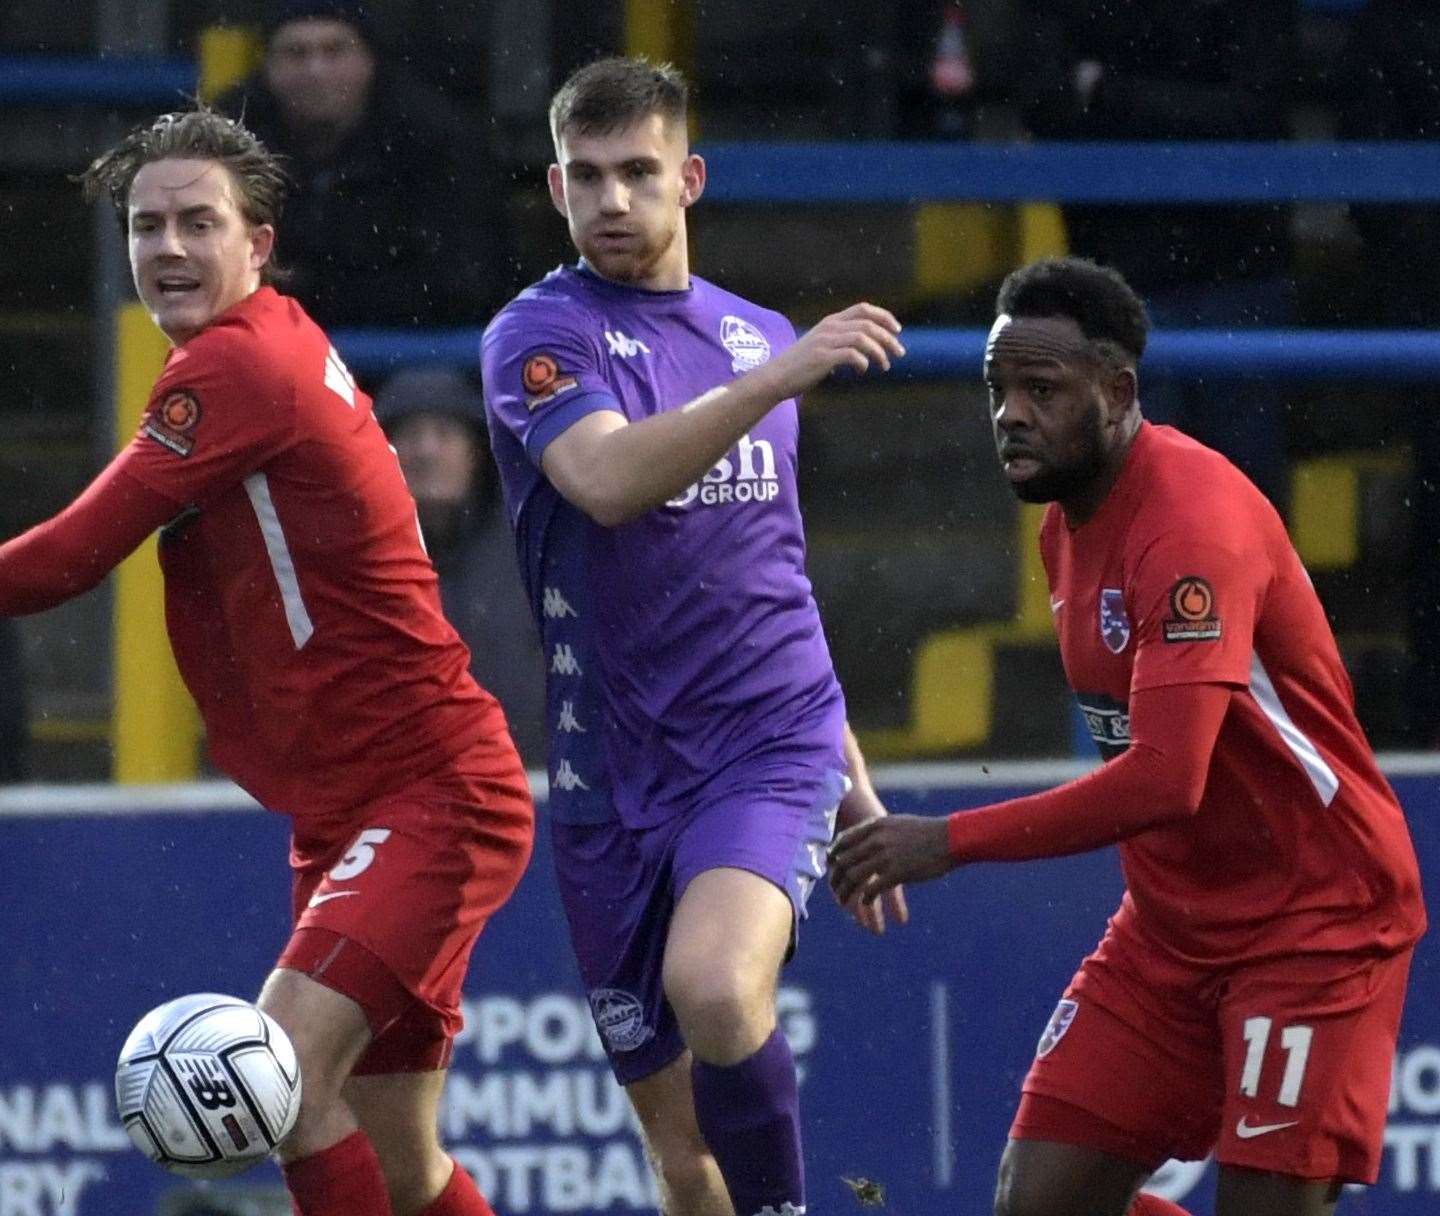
{"left": 331, "top": 326, "right": 1440, "bottom": 382}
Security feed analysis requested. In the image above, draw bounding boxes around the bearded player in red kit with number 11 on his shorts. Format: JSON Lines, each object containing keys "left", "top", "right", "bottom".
{"left": 832, "top": 258, "right": 1426, "bottom": 1216}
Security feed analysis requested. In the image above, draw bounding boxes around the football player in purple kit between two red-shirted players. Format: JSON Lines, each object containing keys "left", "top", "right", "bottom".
{"left": 482, "top": 59, "right": 906, "bottom": 1216}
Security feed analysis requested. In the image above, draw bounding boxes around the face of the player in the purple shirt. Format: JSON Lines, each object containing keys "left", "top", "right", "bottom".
{"left": 550, "top": 114, "right": 706, "bottom": 290}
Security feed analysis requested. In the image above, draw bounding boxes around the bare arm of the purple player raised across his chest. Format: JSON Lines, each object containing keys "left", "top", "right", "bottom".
{"left": 541, "top": 304, "right": 904, "bottom": 527}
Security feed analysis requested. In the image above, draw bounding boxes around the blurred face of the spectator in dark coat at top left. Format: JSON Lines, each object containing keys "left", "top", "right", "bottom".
{"left": 265, "top": 17, "right": 374, "bottom": 130}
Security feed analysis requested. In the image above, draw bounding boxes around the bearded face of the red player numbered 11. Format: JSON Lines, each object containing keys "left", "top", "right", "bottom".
{"left": 985, "top": 317, "right": 1109, "bottom": 503}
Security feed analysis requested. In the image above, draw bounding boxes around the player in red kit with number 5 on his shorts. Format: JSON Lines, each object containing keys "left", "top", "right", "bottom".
{"left": 0, "top": 109, "right": 533, "bottom": 1216}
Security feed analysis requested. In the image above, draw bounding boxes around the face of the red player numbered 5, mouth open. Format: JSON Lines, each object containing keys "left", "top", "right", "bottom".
{"left": 128, "top": 160, "right": 275, "bottom": 346}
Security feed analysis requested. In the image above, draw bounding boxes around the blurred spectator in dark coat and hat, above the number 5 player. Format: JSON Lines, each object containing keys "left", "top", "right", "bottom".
{"left": 217, "top": 0, "right": 516, "bottom": 328}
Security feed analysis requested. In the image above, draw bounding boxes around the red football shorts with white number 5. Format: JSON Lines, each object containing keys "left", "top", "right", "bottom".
{"left": 276, "top": 754, "right": 534, "bottom": 1073}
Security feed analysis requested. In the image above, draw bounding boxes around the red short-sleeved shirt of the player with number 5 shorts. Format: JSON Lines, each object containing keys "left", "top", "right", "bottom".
{"left": 118, "top": 288, "right": 514, "bottom": 817}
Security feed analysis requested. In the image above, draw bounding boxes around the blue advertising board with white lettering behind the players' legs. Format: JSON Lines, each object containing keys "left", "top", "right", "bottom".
{"left": 0, "top": 756, "right": 1440, "bottom": 1216}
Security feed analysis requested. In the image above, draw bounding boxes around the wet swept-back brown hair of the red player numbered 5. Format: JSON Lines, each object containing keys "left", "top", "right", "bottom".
{"left": 78, "top": 105, "right": 289, "bottom": 282}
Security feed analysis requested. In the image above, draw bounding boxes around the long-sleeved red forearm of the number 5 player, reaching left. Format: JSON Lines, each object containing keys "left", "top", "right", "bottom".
{"left": 0, "top": 458, "right": 180, "bottom": 617}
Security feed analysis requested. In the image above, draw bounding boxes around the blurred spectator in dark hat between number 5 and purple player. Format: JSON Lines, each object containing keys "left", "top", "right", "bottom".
{"left": 374, "top": 366, "right": 546, "bottom": 768}
